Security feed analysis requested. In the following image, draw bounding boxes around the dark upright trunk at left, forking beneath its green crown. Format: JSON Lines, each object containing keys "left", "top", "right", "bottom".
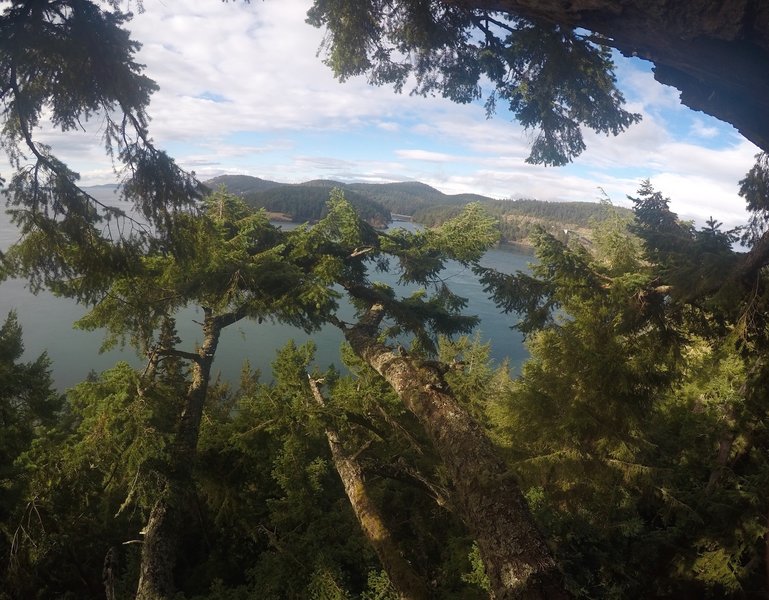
{"left": 136, "top": 308, "right": 231, "bottom": 600}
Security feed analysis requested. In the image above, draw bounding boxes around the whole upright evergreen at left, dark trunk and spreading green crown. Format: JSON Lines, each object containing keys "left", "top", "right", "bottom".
{"left": 2, "top": 186, "right": 336, "bottom": 598}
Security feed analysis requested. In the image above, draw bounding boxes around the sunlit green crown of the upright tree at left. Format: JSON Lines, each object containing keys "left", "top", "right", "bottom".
{"left": 73, "top": 191, "right": 336, "bottom": 353}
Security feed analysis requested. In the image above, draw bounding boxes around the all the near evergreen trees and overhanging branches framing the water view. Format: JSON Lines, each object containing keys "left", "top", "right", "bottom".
{"left": 0, "top": 0, "right": 769, "bottom": 600}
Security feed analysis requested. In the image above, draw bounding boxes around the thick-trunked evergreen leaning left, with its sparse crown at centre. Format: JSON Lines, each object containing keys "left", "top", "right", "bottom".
{"left": 292, "top": 199, "right": 567, "bottom": 598}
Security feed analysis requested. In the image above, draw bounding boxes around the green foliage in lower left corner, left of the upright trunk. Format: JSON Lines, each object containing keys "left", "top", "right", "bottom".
{"left": 1, "top": 364, "right": 171, "bottom": 598}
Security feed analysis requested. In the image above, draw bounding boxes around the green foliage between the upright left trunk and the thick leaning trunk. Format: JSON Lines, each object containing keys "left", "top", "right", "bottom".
{"left": 186, "top": 330, "right": 488, "bottom": 598}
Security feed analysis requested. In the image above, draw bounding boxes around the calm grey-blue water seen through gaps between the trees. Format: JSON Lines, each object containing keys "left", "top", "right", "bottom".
{"left": 0, "top": 212, "right": 532, "bottom": 390}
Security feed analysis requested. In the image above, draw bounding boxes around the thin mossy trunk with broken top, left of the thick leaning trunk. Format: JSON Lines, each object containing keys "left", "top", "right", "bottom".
{"left": 307, "top": 375, "right": 430, "bottom": 600}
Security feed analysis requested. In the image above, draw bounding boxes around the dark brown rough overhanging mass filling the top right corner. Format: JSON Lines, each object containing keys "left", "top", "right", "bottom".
{"left": 452, "top": 0, "right": 769, "bottom": 151}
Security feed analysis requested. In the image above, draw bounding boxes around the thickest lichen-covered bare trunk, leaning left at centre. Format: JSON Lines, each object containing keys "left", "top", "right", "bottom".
{"left": 338, "top": 305, "right": 570, "bottom": 599}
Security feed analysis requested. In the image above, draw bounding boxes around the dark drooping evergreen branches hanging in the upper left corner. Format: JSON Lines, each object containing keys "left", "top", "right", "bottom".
{"left": 0, "top": 0, "right": 210, "bottom": 310}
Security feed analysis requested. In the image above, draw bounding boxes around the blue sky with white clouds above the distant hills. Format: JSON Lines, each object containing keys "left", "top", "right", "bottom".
{"left": 19, "top": 0, "right": 759, "bottom": 227}
